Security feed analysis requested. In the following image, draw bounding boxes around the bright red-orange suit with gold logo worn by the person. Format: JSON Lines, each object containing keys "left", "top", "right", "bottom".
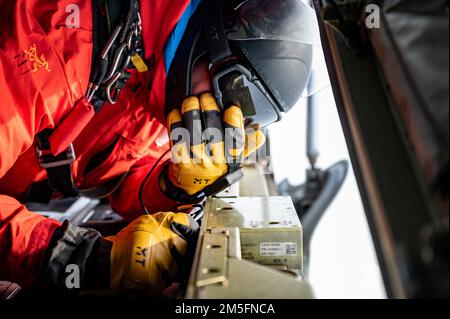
{"left": 0, "top": 0, "right": 190, "bottom": 287}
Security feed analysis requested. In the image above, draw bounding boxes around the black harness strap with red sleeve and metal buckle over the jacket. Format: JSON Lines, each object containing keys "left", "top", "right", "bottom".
{"left": 30, "top": 0, "right": 144, "bottom": 197}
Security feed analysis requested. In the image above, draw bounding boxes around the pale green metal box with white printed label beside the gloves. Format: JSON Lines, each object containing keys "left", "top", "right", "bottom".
{"left": 204, "top": 197, "right": 303, "bottom": 271}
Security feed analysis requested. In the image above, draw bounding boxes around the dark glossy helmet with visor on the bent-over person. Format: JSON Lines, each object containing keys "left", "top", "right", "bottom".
{"left": 166, "top": 0, "right": 318, "bottom": 127}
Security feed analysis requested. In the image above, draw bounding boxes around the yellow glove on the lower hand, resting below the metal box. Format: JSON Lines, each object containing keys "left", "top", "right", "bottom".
{"left": 106, "top": 213, "right": 199, "bottom": 295}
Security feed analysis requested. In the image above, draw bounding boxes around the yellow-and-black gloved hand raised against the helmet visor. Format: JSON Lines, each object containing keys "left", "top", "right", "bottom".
{"left": 168, "top": 93, "right": 265, "bottom": 195}
